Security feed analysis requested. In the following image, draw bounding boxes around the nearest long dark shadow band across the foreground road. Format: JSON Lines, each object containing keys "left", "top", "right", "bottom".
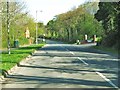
{"left": 3, "top": 75, "right": 111, "bottom": 87}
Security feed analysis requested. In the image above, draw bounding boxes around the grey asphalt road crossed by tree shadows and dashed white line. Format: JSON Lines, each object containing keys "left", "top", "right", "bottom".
{"left": 2, "top": 41, "right": 118, "bottom": 88}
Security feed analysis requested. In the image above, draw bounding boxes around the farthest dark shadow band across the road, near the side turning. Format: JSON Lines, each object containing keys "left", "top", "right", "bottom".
{"left": 39, "top": 44, "right": 111, "bottom": 54}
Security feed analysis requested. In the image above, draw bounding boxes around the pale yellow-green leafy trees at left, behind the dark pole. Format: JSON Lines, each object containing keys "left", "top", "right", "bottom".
{"left": 2, "top": 2, "right": 38, "bottom": 48}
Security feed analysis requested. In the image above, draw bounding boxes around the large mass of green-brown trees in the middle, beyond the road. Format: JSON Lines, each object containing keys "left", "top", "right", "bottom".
{"left": 47, "top": 3, "right": 103, "bottom": 43}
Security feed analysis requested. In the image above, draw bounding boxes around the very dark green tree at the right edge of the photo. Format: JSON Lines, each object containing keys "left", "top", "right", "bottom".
{"left": 95, "top": 2, "right": 120, "bottom": 47}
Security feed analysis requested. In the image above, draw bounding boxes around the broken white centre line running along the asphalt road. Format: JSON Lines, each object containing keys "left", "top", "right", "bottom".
{"left": 61, "top": 46, "right": 118, "bottom": 89}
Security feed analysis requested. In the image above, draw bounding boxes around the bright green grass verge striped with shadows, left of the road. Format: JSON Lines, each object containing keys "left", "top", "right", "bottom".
{"left": 0, "top": 44, "right": 44, "bottom": 74}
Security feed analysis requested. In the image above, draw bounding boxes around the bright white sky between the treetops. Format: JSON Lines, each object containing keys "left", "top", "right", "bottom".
{"left": 24, "top": 0, "right": 86, "bottom": 24}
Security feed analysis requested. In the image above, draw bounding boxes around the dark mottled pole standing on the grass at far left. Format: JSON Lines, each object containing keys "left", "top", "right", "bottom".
{"left": 7, "top": 1, "right": 10, "bottom": 54}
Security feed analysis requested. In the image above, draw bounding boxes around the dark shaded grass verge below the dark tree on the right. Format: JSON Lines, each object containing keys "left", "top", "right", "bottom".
{"left": 93, "top": 46, "right": 118, "bottom": 54}
